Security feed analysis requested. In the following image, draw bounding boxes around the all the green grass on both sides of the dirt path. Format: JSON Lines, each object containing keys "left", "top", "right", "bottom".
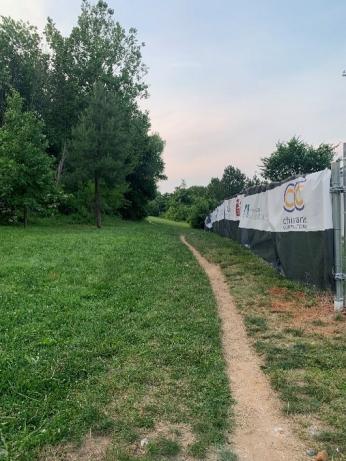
{"left": 0, "top": 218, "right": 346, "bottom": 461}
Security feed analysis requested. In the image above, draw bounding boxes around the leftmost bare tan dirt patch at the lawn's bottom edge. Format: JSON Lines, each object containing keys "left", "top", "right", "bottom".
{"left": 40, "top": 434, "right": 111, "bottom": 461}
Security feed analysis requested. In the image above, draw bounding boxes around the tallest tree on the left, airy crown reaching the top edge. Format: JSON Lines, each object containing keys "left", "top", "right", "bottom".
{"left": 45, "top": 0, "right": 147, "bottom": 181}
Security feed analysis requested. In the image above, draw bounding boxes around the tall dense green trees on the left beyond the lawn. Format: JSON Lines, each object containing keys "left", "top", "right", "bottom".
{"left": 0, "top": 0, "right": 165, "bottom": 227}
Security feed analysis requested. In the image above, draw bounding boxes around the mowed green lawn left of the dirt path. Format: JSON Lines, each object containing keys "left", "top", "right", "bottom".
{"left": 0, "top": 221, "right": 231, "bottom": 461}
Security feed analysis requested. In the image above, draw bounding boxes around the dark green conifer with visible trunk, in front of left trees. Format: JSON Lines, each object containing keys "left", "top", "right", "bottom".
{"left": 67, "top": 82, "right": 135, "bottom": 228}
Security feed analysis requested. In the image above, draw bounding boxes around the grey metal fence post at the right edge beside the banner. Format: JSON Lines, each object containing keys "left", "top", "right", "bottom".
{"left": 331, "top": 160, "right": 345, "bottom": 311}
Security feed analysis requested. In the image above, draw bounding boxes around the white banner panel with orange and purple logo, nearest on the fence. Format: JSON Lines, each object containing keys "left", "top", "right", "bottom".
{"left": 239, "top": 169, "right": 333, "bottom": 232}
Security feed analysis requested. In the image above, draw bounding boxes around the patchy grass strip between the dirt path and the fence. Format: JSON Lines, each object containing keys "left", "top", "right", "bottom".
{"left": 188, "top": 230, "right": 346, "bottom": 460}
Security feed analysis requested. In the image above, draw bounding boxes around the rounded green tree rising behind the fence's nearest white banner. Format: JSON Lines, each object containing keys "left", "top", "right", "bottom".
{"left": 261, "top": 137, "right": 335, "bottom": 181}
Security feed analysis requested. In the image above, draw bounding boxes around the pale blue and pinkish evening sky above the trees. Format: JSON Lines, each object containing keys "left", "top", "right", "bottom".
{"left": 0, "top": 0, "right": 346, "bottom": 192}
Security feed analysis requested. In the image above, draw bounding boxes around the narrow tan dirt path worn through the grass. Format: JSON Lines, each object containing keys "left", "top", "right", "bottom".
{"left": 181, "top": 236, "right": 306, "bottom": 461}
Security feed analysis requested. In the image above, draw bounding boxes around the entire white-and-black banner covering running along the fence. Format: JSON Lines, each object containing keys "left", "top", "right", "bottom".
{"left": 206, "top": 170, "right": 334, "bottom": 288}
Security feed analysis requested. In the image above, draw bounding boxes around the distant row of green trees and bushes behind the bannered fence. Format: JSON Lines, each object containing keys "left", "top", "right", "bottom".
{"left": 149, "top": 137, "right": 335, "bottom": 228}
